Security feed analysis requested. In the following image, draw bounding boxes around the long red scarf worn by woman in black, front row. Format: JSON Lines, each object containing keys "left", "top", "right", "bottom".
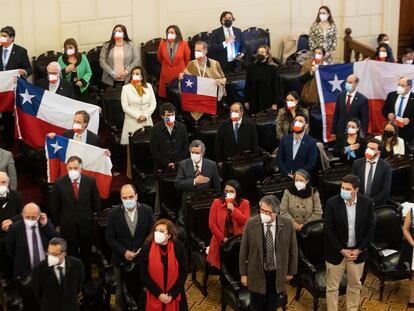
{"left": 145, "top": 241, "right": 181, "bottom": 311}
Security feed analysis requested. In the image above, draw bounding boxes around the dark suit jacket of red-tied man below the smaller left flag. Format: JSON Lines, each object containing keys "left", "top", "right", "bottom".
{"left": 50, "top": 174, "right": 101, "bottom": 240}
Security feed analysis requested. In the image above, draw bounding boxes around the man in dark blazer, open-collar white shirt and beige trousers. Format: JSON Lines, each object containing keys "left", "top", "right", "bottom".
{"left": 324, "top": 175, "right": 375, "bottom": 310}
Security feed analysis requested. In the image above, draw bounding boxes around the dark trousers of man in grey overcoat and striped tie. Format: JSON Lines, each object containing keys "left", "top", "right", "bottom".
{"left": 250, "top": 270, "right": 277, "bottom": 311}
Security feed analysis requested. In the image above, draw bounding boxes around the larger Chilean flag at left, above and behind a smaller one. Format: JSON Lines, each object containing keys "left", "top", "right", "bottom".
{"left": 16, "top": 79, "right": 100, "bottom": 148}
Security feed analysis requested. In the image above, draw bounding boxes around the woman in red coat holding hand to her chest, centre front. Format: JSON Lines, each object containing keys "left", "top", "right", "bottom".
{"left": 207, "top": 180, "right": 250, "bottom": 269}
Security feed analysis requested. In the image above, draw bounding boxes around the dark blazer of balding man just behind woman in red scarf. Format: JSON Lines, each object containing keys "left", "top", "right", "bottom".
{"left": 105, "top": 203, "right": 154, "bottom": 267}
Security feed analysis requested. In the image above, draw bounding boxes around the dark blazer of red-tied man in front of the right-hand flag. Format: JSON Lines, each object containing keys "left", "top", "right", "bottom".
{"left": 332, "top": 91, "right": 369, "bottom": 135}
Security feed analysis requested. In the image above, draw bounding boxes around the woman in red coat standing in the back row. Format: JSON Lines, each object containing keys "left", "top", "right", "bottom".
{"left": 158, "top": 25, "right": 190, "bottom": 97}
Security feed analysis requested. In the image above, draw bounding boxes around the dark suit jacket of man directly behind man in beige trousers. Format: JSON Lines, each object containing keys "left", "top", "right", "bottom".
{"left": 352, "top": 158, "right": 392, "bottom": 206}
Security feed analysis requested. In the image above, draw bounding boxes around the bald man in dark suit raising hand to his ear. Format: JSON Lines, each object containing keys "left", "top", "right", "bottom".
{"left": 6, "top": 202, "right": 59, "bottom": 278}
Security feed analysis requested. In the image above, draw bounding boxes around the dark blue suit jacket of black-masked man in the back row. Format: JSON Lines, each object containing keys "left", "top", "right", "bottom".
{"left": 209, "top": 26, "right": 245, "bottom": 71}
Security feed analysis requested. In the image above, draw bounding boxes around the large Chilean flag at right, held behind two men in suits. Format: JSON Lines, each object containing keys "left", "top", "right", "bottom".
{"left": 316, "top": 60, "right": 414, "bottom": 142}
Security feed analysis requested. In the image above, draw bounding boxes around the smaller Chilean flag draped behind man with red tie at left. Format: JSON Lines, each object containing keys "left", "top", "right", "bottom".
{"left": 45, "top": 135, "right": 112, "bottom": 199}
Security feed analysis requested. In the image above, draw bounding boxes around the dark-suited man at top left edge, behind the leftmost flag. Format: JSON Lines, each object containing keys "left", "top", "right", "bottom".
{"left": 0, "top": 26, "right": 33, "bottom": 148}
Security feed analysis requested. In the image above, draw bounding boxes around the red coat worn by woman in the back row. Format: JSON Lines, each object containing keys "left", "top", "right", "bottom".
{"left": 157, "top": 40, "right": 190, "bottom": 97}
